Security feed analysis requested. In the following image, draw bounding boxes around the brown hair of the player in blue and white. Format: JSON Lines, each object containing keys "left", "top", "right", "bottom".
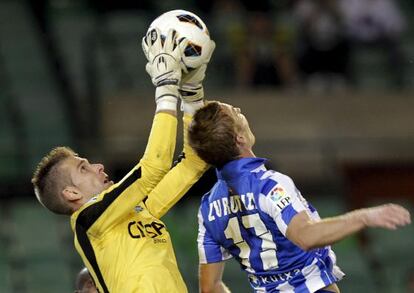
{"left": 188, "top": 101, "right": 240, "bottom": 167}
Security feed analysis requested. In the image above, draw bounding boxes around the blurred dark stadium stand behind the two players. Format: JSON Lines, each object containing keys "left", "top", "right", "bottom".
{"left": 0, "top": 0, "right": 414, "bottom": 293}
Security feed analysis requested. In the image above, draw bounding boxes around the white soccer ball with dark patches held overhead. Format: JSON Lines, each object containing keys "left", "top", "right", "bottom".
{"left": 147, "top": 10, "right": 214, "bottom": 70}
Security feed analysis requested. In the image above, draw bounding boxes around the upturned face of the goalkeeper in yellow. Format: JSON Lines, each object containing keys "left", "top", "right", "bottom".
{"left": 62, "top": 156, "right": 114, "bottom": 206}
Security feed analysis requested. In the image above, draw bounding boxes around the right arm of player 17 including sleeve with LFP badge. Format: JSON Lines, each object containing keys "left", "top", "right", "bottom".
{"left": 260, "top": 173, "right": 410, "bottom": 251}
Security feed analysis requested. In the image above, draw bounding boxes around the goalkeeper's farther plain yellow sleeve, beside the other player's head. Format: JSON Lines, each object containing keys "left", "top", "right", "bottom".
{"left": 145, "top": 114, "right": 208, "bottom": 218}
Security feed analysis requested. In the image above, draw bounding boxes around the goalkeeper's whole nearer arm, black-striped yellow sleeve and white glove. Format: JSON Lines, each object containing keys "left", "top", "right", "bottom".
{"left": 72, "top": 29, "right": 186, "bottom": 235}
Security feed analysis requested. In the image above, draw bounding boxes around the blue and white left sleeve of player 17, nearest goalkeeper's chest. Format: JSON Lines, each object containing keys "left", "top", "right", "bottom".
{"left": 197, "top": 206, "right": 232, "bottom": 264}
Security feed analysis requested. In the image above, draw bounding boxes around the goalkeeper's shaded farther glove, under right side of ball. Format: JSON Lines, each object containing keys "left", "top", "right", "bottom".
{"left": 180, "top": 40, "right": 216, "bottom": 103}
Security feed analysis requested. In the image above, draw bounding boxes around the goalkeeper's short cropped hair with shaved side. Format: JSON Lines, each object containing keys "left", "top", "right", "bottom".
{"left": 32, "top": 147, "right": 76, "bottom": 215}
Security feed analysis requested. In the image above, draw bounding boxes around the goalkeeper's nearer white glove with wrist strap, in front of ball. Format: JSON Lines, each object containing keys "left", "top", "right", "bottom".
{"left": 142, "top": 29, "right": 188, "bottom": 111}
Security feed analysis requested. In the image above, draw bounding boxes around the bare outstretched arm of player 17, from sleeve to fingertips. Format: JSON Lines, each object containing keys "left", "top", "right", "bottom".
{"left": 286, "top": 204, "right": 411, "bottom": 250}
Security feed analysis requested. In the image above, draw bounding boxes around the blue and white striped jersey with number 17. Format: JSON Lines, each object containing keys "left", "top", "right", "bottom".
{"left": 197, "top": 158, "right": 343, "bottom": 293}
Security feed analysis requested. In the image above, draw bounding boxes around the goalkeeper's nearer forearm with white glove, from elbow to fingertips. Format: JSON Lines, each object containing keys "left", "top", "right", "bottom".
{"left": 140, "top": 29, "right": 186, "bottom": 190}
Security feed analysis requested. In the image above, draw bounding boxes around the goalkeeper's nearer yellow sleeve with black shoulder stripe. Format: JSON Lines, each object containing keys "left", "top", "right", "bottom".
{"left": 71, "top": 113, "right": 177, "bottom": 237}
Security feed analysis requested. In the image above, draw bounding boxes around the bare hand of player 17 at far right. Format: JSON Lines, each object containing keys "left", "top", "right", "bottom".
{"left": 362, "top": 204, "right": 411, "bottom": 230}
